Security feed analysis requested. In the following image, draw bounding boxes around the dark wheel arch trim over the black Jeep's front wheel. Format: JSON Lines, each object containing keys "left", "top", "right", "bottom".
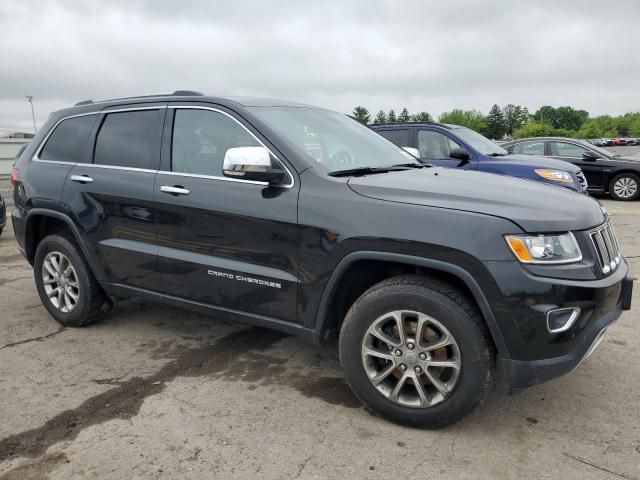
{"left": 315, "top": 251, "right": 509, "bottom": 358}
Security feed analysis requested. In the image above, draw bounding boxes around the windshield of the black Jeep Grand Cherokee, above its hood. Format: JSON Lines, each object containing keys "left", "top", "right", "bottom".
{"left": 251, "top": 107, "right": 420, "bottom": 173}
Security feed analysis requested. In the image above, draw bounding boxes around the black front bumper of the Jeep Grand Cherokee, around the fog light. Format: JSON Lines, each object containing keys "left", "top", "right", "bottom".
{"left": 483, "top": 253, "right": 633, "bottom": 390}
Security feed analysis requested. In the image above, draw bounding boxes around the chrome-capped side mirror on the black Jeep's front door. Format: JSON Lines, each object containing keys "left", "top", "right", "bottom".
{"left": 222, "top": 147, "right": 285, "bottom": 185}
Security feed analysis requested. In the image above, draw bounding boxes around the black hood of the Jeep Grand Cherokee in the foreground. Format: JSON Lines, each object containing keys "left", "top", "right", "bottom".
{"left": 348, "top": 167, "right": 604, "bottom": 232}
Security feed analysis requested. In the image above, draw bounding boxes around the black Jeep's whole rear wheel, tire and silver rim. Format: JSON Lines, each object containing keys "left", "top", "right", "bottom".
{"left": 33, "top": 235, "right": 111, "bottom": 327}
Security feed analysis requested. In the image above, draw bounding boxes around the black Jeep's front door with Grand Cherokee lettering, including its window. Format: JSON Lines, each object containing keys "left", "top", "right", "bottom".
{"left": 155, "top": 106, "right": 299, "bottom": 321}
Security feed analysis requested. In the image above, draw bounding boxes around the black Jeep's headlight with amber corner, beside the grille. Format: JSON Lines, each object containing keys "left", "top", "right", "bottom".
{"left": 504, "top": 232, "right": 582, "bottom": 263}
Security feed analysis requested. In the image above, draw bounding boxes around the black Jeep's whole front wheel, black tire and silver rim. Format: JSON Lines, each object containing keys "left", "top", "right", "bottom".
{"left": 339, "top": 275, "right": 495, "bottom": 428}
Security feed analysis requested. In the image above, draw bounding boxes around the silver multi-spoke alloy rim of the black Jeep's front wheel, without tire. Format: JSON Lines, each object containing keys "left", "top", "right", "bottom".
{"left": 361, "top": 310, "right": 462, "bottom": 408}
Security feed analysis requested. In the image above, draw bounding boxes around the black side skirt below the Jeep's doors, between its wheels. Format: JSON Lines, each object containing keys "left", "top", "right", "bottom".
{"left": 101, "top": 282, "right": 321, "bottom": 345}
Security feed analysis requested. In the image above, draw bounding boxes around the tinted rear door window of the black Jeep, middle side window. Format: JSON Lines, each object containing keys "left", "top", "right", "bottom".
{"left": 93, "top": 110, "right": 160, "bottom": 170}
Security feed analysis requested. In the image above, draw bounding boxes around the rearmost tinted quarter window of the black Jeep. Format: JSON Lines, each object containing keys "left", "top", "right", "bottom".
{"left": 40, "top": 115, "right": 98, "bottom": 163}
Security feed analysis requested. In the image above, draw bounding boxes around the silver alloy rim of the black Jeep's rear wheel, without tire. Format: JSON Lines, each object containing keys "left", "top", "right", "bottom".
{"left": 42, "top": 252, "right": 80, "bottom": 313}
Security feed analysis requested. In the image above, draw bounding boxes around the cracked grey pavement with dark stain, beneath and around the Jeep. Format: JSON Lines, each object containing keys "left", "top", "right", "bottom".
{"left": 0, "top": 196, "right": 640, "bottom": 480}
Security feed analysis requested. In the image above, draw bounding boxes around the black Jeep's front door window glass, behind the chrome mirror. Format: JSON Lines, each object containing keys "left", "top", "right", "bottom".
{"left": 171, "top": 109, "right": 261, "bottom": 177}
